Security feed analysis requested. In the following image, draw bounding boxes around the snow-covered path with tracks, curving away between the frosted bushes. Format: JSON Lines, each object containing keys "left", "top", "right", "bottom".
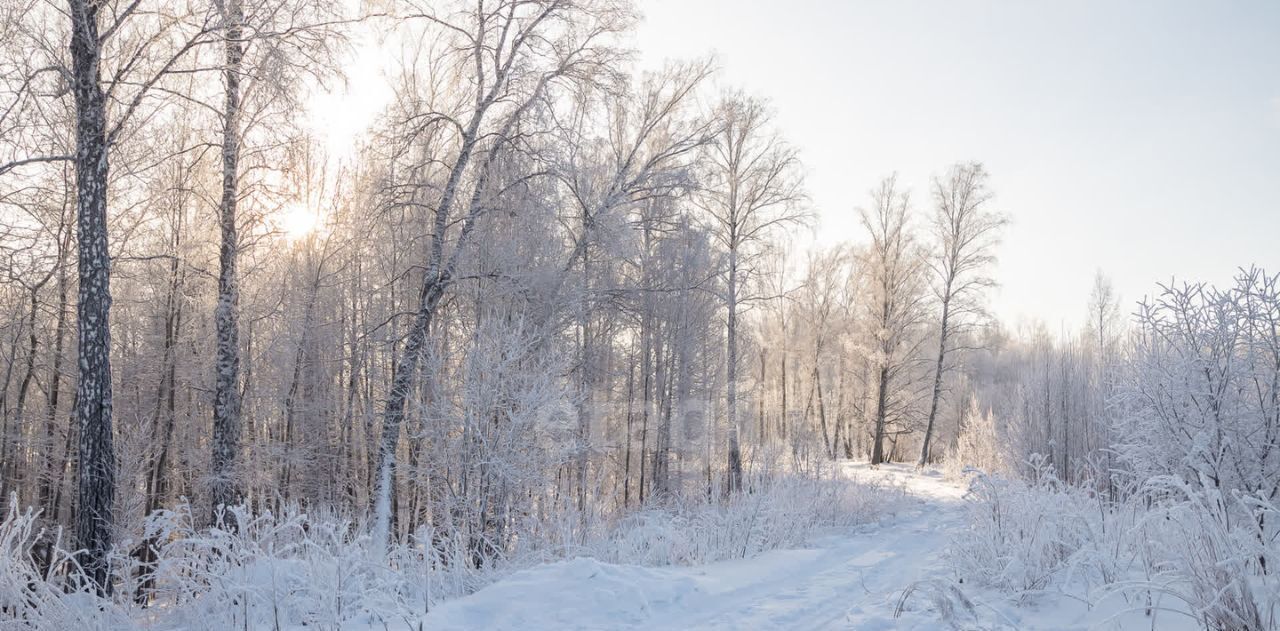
{"left": 425, "top": 466, "right": 988, "bottom": 631}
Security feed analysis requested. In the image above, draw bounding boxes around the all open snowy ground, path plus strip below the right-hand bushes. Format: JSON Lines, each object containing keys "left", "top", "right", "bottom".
{"left": 422, "top": 465, "right": 1193, "bottom": 631}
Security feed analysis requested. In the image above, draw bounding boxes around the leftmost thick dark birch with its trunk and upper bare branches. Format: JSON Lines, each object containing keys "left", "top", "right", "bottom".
{"left": 0, "top": 0, "right": 216, "bottom": 593}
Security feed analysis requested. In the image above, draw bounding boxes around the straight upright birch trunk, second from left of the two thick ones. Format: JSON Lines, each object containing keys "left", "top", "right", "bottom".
{"left": 210, "top": 0, "right": 244, "bottom": 519}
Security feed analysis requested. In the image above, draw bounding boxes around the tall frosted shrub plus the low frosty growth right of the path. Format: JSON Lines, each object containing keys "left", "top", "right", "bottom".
{"left": 950, "top": 270, "right": 1280, "bottom": 630}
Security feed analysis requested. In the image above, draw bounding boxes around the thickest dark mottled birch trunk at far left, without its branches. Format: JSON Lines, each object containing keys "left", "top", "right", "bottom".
{"left": 68, "top": 0, "right": 115, "bottom": 594}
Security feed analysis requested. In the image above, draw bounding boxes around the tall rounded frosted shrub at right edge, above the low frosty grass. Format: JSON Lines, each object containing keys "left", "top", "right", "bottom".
{"left": 1116, "top": 270, "right": 1280, "bottom": 506}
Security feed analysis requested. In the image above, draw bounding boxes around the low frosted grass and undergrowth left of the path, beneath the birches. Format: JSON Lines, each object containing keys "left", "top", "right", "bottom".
{"left": 0, "top": 506, "right": 496, "bottom": 631}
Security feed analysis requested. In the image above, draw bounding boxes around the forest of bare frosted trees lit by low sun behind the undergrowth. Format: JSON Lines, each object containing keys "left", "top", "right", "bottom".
{"left": 0, "top": 0, "right": 1280, "bottom": 629}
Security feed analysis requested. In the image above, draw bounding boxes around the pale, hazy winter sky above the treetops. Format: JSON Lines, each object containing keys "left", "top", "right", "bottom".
{"left": 312, "top": 0, "right": 1280, "bottom": 333}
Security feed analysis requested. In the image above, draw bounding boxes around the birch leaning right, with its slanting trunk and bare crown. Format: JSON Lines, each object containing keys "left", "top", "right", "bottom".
{"left": 374, "top": 0, "right": 630, "bottom": 545}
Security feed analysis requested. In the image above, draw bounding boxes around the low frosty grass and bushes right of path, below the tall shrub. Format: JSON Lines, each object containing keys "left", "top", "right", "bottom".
{"left": 948, "top": 461, "right": 1280, "bottom": 631}
